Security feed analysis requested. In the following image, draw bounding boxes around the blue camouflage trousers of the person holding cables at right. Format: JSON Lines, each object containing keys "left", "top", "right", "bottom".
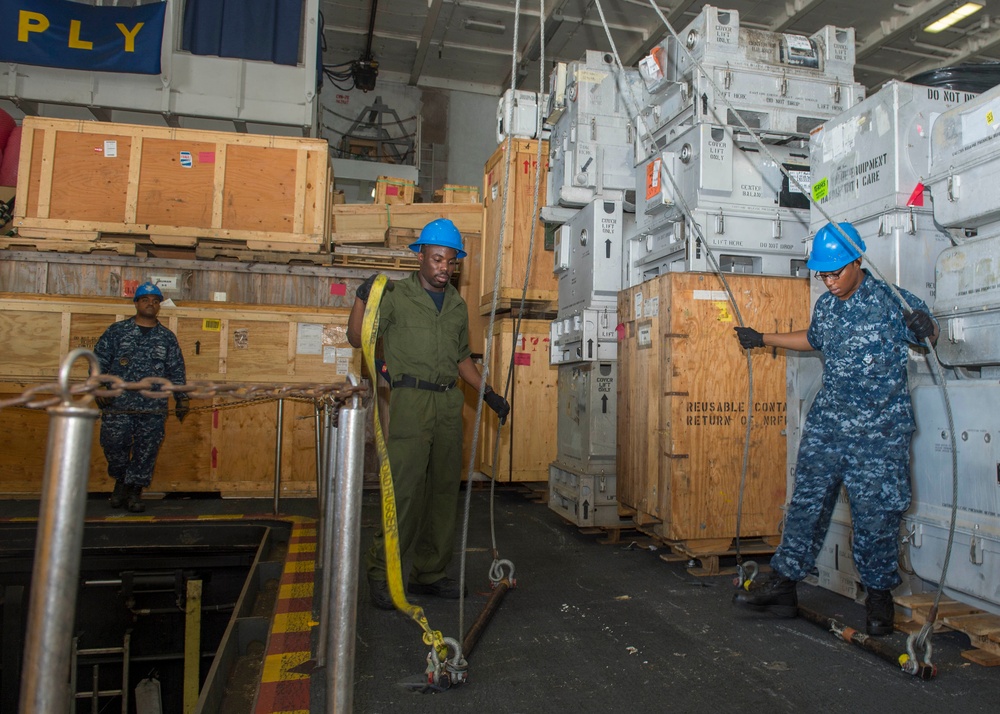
{"left": 771, "top": 420, "right": 911, "bottom": 590}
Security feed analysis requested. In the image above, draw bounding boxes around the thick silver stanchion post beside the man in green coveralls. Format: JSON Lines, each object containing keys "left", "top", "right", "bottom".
{"left": 326, "top": 396, "right": 365, "bottom": 714}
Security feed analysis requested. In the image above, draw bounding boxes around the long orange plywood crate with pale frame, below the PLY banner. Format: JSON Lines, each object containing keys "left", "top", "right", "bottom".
{"left": 14, "top": 117, "right": 333, "bottom": 253}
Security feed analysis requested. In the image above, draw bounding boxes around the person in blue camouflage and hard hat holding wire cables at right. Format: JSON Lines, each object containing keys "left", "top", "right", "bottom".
{"left": 733, "top": 223, "right": 937, "bottom": 635}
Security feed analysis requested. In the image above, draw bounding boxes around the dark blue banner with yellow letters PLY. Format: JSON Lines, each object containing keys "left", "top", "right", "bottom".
{"left": 0, "top": 0, "right": 167, "bottom": 74}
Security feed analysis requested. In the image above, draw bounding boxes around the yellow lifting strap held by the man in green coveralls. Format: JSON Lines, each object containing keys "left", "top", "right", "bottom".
{"left": 361, "top": 274, "right": 448, "bottom": 661}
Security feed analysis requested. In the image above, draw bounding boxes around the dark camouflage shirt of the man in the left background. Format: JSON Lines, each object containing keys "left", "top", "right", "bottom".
{"left": 94, "top": 317, "right": 186, "bottom": 412}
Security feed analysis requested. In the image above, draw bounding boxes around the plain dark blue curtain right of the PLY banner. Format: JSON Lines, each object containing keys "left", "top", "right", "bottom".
{"left": 181, "top": 0, "right": 304, "bottom": 65}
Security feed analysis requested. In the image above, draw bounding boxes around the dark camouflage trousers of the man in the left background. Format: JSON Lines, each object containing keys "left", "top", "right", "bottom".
{"left": 101, "top": 411, "right": 167, "bottom": 488}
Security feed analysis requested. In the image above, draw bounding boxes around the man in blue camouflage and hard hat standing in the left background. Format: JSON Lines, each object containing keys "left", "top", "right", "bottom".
{"left": 94, "top": 283, "right": 189, "bottom": 513}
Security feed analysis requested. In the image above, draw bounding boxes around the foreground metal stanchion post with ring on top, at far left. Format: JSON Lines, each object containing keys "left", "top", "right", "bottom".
{"left": 19, "top": 349, "right": 100, "bottom": 714}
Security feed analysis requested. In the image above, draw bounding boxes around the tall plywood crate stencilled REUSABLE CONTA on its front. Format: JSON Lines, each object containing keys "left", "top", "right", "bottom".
{"left": 617, "top": 273, "right": 809, "bottom": 552}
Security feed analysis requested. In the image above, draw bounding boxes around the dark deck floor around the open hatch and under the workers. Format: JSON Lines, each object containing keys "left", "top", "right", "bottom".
{"left": 3, "top": 487, "right": 1000, "bottom": 714}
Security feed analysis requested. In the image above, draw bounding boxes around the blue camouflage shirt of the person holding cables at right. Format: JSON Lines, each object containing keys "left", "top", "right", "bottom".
{"left": 808, "top": 270, "right": 930, "bottom": 438}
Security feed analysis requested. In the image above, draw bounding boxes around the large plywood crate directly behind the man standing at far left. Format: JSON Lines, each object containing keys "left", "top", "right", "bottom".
{"left": 0, "top": 293, "right": 360, "bottom": 496}
